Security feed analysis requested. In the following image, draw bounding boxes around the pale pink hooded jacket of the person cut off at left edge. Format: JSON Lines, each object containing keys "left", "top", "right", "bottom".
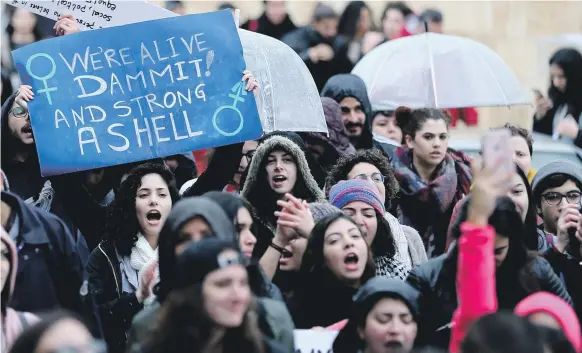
{"left": 0, "top": 231, "right": 39, "bottom": 351}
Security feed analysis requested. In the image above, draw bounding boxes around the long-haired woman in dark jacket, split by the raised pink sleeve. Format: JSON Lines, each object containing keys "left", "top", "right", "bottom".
{"left": 408, "top": 180, "right": 572, "bottom": 348}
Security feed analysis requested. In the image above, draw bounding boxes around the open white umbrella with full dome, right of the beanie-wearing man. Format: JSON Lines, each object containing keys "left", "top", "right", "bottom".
{"left": 352, "top": 33, "right": 531, "bottom": 109}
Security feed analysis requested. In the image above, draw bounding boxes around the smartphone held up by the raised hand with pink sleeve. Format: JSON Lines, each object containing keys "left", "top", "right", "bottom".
{"left": 482, "top": 129, "right": 515, "bottom": 173}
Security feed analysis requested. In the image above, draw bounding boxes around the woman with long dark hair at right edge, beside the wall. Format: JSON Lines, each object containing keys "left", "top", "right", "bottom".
{"left": 533, "top": 48, "right": 582, "bottom": 147}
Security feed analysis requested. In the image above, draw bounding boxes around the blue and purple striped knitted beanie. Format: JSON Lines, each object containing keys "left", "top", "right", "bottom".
{"left": 329, "top": 179, "right": 386, "bottom": 215}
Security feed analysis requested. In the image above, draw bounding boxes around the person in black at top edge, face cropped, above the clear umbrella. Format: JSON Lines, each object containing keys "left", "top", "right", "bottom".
{"left": 241, "top": 0, "right": 297, "bottom": 40}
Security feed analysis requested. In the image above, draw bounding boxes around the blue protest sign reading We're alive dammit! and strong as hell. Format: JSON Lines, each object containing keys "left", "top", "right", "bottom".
{"left": 12, "top": 10, "right": 262, "bottom": 176}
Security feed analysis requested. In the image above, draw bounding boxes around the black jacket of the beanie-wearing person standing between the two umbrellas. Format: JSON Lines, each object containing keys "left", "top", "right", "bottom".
{"left": 281, "top": 26, "right": 354, "bottom": 91}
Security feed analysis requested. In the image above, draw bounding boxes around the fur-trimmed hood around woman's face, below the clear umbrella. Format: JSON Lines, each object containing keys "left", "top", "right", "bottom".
{"left": 241, "top": 135, "right": 326, "bottom": 227}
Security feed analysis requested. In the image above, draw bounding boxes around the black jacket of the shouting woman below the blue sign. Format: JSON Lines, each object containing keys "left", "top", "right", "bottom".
{"left": 87, "top": 241, "right": 143, "bottom": 353}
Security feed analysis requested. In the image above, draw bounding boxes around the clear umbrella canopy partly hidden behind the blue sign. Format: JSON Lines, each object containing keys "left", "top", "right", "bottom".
{"left": 238, "top": 29, "right": 327, "bottom": 133}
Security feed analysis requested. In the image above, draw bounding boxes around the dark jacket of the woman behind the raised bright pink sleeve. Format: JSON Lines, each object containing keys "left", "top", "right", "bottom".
{"left": 407, "top": 253, "right": 572, "bottom": 349}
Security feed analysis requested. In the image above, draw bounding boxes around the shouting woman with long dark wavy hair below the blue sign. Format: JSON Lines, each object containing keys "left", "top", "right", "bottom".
{"left": 87, "top": 163, "right": 178, "bottom": 353}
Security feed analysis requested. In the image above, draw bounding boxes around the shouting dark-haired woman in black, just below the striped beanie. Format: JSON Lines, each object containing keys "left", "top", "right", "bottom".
{"left": 288, "top": 213, "right": 376, "bottom": 329}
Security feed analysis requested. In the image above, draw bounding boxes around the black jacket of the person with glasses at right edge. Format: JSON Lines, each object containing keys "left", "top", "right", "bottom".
{"left": 544, "top": 247, "right": 582, "bottom": 322}
